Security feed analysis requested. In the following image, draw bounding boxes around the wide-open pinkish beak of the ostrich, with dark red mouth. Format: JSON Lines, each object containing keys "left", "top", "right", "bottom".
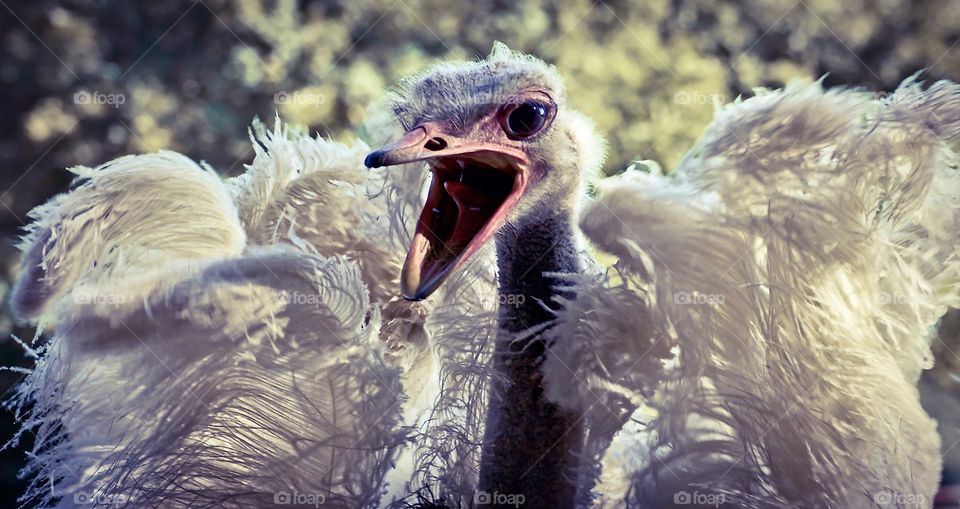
{"left": 364, "top": 122, "right": 530, "bottom": 300}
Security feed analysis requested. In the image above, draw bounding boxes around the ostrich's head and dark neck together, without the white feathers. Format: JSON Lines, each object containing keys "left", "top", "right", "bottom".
{"left": 365, "top": 49, "right": 603, "bottom": 508}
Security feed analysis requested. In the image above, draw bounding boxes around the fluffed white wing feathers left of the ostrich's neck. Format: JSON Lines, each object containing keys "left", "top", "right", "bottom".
{"left": 10, "top": 133, "right": 406, "bottom": 507}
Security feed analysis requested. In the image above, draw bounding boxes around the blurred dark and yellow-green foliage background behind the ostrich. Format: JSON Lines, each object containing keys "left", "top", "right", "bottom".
{"left": 0, "top": 0, "right": 960, "bottom": 507}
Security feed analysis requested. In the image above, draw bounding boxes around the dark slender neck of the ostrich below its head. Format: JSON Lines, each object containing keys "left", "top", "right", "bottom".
{"left": 480, "top": 206, "right": 583, "bottom": 509}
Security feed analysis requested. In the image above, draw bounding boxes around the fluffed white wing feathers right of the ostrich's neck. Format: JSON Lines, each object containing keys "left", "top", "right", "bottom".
{"left": 547, "top": 81, "right": 960, "bottom": 508}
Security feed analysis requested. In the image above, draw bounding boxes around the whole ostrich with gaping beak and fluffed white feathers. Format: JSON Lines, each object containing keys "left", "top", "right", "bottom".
{"left": 11, "top": 45, "right": 960, "bottom": 508}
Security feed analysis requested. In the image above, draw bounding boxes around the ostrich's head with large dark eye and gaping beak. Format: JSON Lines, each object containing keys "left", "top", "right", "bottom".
{"left": 365, "top": 43, "right": 603, "bottom": 300}
